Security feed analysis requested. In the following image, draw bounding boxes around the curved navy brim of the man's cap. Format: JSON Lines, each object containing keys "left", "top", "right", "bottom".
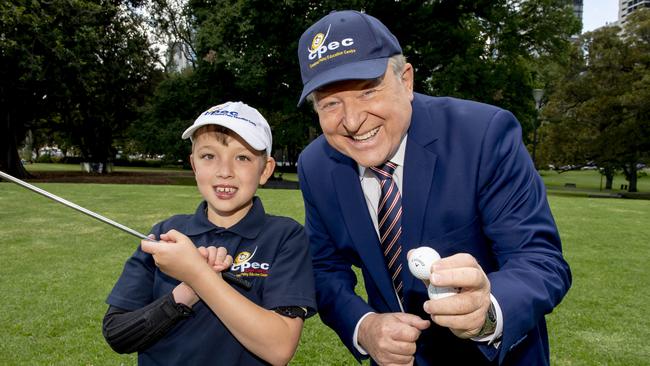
{"left": 298, "top": 57, "right": 390, "bottom": 107}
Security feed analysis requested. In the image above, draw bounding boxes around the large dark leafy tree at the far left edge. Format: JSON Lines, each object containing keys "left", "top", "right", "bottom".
{"left": 0, "top": 0, "right": 153, "bottom": 176}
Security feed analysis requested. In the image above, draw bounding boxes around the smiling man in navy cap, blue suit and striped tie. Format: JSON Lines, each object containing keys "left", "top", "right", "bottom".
{"left": 298, "top": 11, "right": 571, "bottom": 365}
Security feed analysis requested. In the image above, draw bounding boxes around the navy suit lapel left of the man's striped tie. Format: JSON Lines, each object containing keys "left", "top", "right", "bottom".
{"left": 332, "top": 150, "right": 400, "bottom": 311}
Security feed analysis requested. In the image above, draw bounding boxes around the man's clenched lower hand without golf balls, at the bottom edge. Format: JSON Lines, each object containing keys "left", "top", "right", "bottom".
{"left": 357, "top": 313, "right": 431, "bottom": 365}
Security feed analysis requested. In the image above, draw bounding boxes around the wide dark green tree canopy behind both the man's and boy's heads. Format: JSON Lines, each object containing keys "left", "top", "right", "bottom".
{"left": 133, "top": 0, "right": 578, "bottom": 163}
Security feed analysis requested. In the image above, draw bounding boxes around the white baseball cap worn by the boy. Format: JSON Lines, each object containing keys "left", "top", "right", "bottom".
{"left": 182, "top": 102, "right": 273, "bottom": 156}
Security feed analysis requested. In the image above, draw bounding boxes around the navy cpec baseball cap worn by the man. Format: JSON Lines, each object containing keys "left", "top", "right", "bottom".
{"left": 298, "top": 10, "right": 402, "bottom": 106}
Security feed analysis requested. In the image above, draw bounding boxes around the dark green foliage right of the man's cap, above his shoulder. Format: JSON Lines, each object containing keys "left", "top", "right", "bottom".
{"left": 398, "top": 0, "right": 579, "bottom": 133}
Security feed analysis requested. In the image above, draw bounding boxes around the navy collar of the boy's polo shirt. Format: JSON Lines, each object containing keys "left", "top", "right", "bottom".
{"left": 186, "top": 197, "right": 266, "bottom": 239}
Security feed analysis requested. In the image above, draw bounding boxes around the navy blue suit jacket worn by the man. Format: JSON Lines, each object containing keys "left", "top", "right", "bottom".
{"left": 298, "top": 93, "right": 571, "bottom": 365}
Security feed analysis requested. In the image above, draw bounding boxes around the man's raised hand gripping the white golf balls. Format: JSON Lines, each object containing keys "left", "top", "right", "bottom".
{"left": 424, "top": 253, "right": 490, "bottom": 338}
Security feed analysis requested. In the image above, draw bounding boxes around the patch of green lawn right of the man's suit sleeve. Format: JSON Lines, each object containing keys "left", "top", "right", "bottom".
{"left": 547, "top": 195, "right": 650, "bottom": 365}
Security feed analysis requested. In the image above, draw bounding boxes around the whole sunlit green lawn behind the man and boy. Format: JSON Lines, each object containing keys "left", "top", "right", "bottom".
{"left": 0, "top": 183, "right": 650, "bottom": 365}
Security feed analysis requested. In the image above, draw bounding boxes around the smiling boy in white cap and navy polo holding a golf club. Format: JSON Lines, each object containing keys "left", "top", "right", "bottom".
{"left": 103, "top": 102, "right": 316, "bottom": 365}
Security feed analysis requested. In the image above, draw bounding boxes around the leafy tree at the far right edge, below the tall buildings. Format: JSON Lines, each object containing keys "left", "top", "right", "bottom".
{"left": 542, "top": 10, "right": 650, "bottom": 192}
